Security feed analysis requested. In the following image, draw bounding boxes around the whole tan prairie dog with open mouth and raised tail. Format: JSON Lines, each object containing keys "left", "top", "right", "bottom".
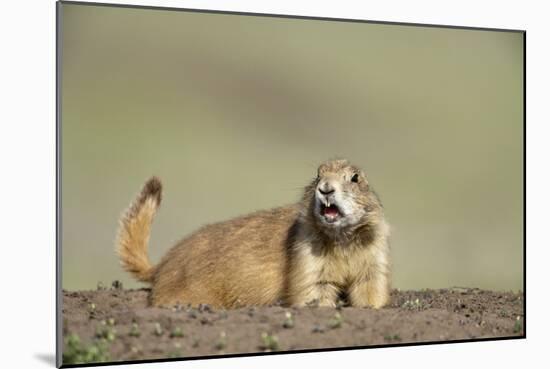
{"left": 116, "top": 160, "right": 390, "bottom": 308}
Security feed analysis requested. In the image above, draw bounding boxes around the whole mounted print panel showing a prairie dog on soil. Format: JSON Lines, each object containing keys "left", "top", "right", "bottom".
{"left": 58, "top": 2, "right": 525, "bottom": 366}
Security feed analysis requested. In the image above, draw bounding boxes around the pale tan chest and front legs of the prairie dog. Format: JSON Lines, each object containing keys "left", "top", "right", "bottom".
{"left": 287, "top": 217, "right": 390, "bottom": 307}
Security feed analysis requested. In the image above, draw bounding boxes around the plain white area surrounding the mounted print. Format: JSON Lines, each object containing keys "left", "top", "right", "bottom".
{"left": 0, "top": 0, "right": 550, "bottom": 368}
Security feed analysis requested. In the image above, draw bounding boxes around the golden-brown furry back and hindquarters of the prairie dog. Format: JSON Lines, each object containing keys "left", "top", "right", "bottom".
{"left": 152, "top": 206, "right": 298, "bottom": 307}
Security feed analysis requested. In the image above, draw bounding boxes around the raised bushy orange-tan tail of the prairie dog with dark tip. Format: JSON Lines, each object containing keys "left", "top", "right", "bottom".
{"left": 116, "top": 177, "right": 162, "bottom": 282}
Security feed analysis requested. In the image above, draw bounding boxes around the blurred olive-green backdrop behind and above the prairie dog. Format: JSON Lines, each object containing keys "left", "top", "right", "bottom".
{"left": 61, "top": 4, "right": 523, "bottom": 290}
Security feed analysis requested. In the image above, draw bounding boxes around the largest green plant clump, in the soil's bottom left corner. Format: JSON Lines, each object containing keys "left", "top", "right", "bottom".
{"left": 63, "top": 333, "right": 110, "bottom": 364}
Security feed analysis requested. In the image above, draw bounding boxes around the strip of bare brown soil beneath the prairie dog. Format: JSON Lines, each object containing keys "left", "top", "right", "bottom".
{"left": 63, "top": 283, "right": 524, "bottom": 364}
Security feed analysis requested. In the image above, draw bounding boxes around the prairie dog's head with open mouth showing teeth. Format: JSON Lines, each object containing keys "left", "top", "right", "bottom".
{"left": 304, "top": 159, "right": 381, "bottom": 234}
